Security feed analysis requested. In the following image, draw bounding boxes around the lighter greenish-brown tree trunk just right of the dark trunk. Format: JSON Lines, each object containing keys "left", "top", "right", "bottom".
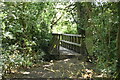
{"left": 85, "top": 2, "right": 94, "bottom": 56}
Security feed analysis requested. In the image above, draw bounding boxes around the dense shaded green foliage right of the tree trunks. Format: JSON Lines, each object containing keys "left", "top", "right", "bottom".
{"left": 86, "top": 3, "right": 118, "bottom": 77}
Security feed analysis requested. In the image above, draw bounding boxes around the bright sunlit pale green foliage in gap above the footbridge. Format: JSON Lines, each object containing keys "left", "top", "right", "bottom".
{"left": 52, "top": 3, "right": 77, "bottom": 34}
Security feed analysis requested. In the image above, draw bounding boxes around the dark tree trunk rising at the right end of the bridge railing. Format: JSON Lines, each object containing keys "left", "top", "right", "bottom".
{"left": 75, "top": 2, "right": 87, "bottom": 55}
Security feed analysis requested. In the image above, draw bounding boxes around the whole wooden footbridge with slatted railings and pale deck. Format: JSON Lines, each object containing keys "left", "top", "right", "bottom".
{"left": 49, "top": 33, "right": 86, "bottom": 55}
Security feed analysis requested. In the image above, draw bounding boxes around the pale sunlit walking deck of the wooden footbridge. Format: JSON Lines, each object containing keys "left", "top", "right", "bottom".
{"left": 59, "top": 46, "right": 81, "bottom": 55}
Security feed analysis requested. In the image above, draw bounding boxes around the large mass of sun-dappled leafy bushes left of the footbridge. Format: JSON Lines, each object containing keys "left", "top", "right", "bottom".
{"left": 1, "top": 2, "right": 54, "bottom": 73}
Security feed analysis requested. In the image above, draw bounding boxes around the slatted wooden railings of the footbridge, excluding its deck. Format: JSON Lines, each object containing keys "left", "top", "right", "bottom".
{"left": 49, "top": 33, "right": 85, "bottom": 53}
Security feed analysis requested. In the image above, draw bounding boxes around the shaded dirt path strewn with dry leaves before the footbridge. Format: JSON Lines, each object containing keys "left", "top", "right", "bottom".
{"left": 5, "top": 58, "right": 99, "bottom": 78}
